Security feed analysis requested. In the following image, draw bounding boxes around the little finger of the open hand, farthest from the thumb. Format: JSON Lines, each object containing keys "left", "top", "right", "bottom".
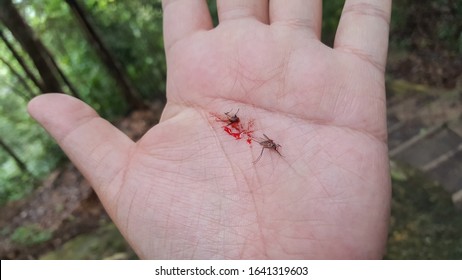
{"left": 334, "top": 0, "right": 391, "bottom": 71}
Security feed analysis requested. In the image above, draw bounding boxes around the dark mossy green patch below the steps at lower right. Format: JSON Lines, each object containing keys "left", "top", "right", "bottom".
{"left": 386, "top": 167, "right": 462, "bottom": 259}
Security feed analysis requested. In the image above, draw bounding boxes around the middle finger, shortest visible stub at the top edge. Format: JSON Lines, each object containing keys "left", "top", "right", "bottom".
{"left": 217, "top": 0, "right": 268, "bottom": 24}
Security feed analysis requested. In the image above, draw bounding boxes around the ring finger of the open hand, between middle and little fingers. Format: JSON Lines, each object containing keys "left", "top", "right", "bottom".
{"left": 270, "top": 0, "right": 322, "bottom": 38}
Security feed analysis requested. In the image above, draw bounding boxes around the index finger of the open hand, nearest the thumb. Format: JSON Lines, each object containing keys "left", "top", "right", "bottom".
{"left": 162, "top": 0, "right": 213, "bottom": 50}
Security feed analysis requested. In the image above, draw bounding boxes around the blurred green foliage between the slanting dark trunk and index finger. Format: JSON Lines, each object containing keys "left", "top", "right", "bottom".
{"left": 85, "top": 0, "right": 166, "bottom": 99}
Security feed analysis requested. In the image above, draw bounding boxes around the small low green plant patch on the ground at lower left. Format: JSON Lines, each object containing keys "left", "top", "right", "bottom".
{"left": 10, "top": 224, "right": 53, "bottom": 246}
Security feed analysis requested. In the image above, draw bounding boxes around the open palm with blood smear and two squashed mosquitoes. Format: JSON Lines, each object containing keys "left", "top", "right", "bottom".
{"left": 29, "top": 0, "right": 391, "bottom": 259}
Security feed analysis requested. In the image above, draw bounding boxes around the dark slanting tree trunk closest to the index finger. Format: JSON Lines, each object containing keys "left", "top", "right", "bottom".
{"left": 66, "top": 0, "right": 146, "bottom": 109}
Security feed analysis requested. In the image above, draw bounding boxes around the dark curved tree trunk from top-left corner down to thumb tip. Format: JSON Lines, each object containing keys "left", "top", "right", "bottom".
{"left": 0, "top": 0, "right": 62, "bottom": 92}
